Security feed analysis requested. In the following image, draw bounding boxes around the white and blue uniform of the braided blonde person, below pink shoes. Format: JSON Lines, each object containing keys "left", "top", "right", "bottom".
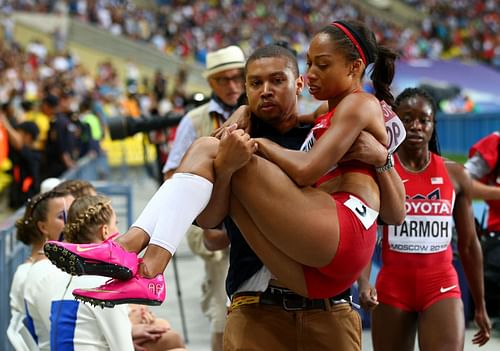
{"left": 24, "top": 260, "right": 134, "bottom": 351}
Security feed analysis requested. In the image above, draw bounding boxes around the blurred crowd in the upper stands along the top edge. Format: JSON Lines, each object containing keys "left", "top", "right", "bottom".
{"left": 4, "top": 0, "right": 500, "bottom": 68}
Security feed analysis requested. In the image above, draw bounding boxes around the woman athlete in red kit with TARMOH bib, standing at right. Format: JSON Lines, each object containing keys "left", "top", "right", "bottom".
{"left": 358, "top": 89, "right": 491, "bottom": 351}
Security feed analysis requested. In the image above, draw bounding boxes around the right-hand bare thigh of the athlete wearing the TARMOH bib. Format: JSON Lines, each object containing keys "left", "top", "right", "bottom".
{"left": 418, "top": 298, "right": 465, "bottom": 351}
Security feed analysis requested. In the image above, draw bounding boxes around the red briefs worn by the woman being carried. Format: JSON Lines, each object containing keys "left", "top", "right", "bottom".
{"left": 303, "top": 192, "right": 377, "bottom": 299}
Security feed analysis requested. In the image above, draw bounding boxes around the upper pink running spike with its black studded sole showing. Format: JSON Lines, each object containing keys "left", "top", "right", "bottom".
{"left": 43, "top": 235, "right": 139, "bottom": 280}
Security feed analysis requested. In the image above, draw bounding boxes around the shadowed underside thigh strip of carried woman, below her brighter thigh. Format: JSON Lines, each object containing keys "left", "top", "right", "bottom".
{"left": 231, "top": 197, "right": 307, "bottom": 296}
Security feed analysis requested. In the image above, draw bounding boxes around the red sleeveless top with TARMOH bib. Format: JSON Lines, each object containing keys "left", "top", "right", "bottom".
{"left": 382, "top": 153, "right": 455, "bottom": 269}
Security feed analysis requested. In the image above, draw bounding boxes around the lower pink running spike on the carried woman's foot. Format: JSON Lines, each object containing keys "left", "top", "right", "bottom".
{"left": 73, "top": 273, "right": 167, "bottom": 307}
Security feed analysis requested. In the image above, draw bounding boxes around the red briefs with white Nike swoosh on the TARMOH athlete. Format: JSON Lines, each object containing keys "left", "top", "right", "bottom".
{"left": 376, "top": 264, "right": 461, "bottom": 312}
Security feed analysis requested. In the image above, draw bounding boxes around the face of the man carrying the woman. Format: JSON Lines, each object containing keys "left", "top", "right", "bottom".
{"left": 246, "top": 57, "right": 304, "bottom": 123}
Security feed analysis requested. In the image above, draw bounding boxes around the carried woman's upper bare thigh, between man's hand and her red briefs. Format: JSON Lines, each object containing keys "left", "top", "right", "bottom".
{"left": 232, "top": 156, "right": 339, "bottom": 267}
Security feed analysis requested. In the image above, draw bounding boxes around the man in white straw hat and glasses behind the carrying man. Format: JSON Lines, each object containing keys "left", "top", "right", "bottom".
{"left": 163, "top": 45, "right": 245, "bottom": 351}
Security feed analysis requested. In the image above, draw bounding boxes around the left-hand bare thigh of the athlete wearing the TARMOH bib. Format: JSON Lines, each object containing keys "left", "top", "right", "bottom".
{"left": 372, "top": 303, "right": 418, "bottom": 351}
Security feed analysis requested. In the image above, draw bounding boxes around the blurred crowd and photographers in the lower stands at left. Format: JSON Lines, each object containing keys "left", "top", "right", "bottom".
{"left": 0, "top": 35, "right": 191, "bottom": 209}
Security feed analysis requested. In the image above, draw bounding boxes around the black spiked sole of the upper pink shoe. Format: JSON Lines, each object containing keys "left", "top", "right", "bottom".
{"left": 43, "top": 243, "right": 133, "bottom": 280}
